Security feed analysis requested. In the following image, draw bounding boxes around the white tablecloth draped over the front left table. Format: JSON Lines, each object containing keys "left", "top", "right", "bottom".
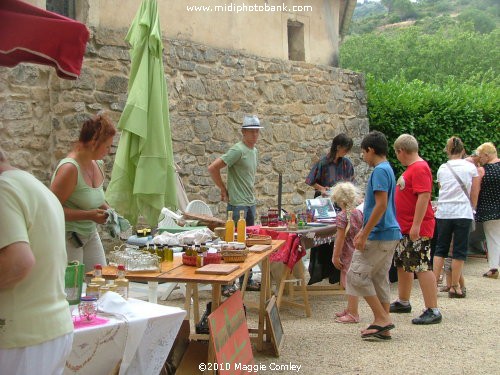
{"left": 64, "top": 299, "right": 186, "bottom": 375}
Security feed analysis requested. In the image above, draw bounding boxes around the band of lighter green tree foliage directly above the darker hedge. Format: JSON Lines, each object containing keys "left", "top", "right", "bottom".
{"left": 340, "top": 24, "right": 500, "bottom": 83}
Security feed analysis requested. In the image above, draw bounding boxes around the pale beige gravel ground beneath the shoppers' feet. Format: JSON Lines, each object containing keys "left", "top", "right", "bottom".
{"left": 158, "top": 258, "right": 500, "bottom": 375}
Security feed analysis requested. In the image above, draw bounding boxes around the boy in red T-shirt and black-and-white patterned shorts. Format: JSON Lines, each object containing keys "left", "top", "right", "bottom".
{"left": 390, "top": 134, "right": 442, "bottom": 324}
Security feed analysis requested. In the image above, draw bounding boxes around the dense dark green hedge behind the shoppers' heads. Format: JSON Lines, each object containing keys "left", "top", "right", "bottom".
{"left": 367, "top": 76, "right": 500, "bottom": 194}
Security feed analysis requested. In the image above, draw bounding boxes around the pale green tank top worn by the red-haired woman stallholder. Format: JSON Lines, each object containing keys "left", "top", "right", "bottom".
{"left": 52, "top": 158, "right": 105, "bottom": 236}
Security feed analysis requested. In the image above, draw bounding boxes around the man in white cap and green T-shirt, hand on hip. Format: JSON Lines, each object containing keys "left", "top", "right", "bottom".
{"left": 208, "top": 115, "right": 263, "bottom": 294}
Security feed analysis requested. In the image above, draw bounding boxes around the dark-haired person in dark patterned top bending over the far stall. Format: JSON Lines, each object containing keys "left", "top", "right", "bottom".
{"left": 306, "top": 133, "right": 354, "bottom": 197}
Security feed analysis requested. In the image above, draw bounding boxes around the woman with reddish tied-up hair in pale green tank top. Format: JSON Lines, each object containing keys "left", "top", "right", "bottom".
{"left": 50, "top": 115, "right": 116, "bottom": 272}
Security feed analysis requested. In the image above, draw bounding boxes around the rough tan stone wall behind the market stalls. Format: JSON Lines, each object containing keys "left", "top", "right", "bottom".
{"left": 0, "top": 30, "right": 368, "bottom": 222}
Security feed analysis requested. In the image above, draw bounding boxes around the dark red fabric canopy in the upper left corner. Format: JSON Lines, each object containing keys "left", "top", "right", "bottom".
{"left": 0, "top": 0, "right": 89, "bottom": 79}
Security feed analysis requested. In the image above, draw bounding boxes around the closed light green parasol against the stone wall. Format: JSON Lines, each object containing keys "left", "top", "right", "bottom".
{"left": 106, "top": 0, "right": 177, "bottom": 226}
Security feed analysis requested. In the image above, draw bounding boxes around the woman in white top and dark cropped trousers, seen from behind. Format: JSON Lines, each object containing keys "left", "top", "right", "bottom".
{"left": 433, "top": 137, "right": 479, "bottom": 298}
